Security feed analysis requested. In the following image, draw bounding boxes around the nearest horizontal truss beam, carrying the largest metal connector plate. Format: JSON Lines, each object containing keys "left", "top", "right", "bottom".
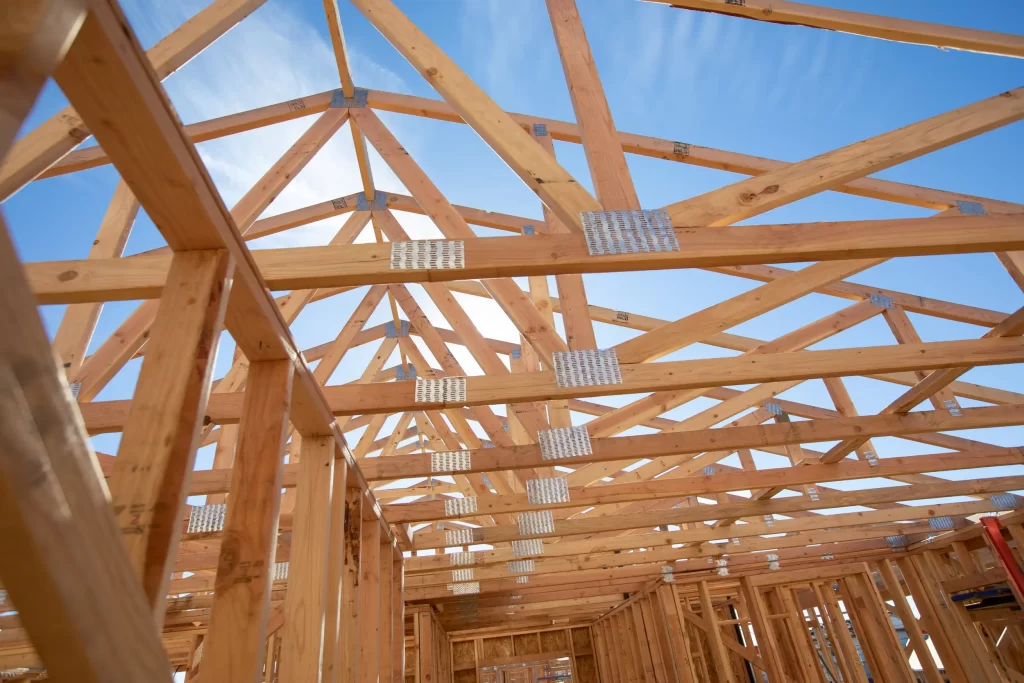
{"left": 28, "top": 214, "right": 1024, "bottom": 305}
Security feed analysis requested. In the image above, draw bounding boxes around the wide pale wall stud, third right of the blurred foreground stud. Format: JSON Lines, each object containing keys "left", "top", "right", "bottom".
{"left": 281, "top": 435, "right": 344, "bottom": 683}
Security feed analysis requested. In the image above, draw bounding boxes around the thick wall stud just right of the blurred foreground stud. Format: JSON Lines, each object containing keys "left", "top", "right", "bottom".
{"left": 110, "top": 250, "right": 231, "bottom": 614}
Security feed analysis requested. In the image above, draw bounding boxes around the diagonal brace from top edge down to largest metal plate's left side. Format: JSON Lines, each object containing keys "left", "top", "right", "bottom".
{"left": 352, "top": 0, "right": 601, "bottom": 231}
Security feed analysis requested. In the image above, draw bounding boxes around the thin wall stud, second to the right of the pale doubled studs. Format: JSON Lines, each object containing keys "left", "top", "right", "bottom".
{"left": 356, "top": 516, "right": 381, "bottom": 683}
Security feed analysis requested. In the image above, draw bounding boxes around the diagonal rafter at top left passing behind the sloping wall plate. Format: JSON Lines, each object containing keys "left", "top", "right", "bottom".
{"left": 0, "top": 0, "right": 265, "bottom": 202}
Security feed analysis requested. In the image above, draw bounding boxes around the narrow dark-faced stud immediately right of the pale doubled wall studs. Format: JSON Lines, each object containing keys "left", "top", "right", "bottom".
{"left": 335, "top": 489, "right": 365, "bottom": 683}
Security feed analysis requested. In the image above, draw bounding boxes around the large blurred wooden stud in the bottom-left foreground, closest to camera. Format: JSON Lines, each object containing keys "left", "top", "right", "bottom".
{"left": 0, "top": 214, "right": 170, "bottom": 683}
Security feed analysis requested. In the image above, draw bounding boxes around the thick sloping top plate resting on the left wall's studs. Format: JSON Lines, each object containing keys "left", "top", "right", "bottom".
{"left": 56, "top": 1, "right": 342, "bottom": 434}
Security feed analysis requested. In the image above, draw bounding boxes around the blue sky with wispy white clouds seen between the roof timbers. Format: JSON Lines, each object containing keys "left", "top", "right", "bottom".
{"left": 5, "top": 0, "right": 1024, "bottom": 489}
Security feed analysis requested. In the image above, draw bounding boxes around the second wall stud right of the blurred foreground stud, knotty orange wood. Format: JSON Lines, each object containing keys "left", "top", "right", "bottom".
{"left": 203, "top": 359, "right": 292, "bottom": 681}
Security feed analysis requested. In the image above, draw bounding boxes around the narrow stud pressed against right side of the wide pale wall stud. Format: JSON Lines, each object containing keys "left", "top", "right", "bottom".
{"left": 321, "top": 452, "right": 348, "bottom": 683}
